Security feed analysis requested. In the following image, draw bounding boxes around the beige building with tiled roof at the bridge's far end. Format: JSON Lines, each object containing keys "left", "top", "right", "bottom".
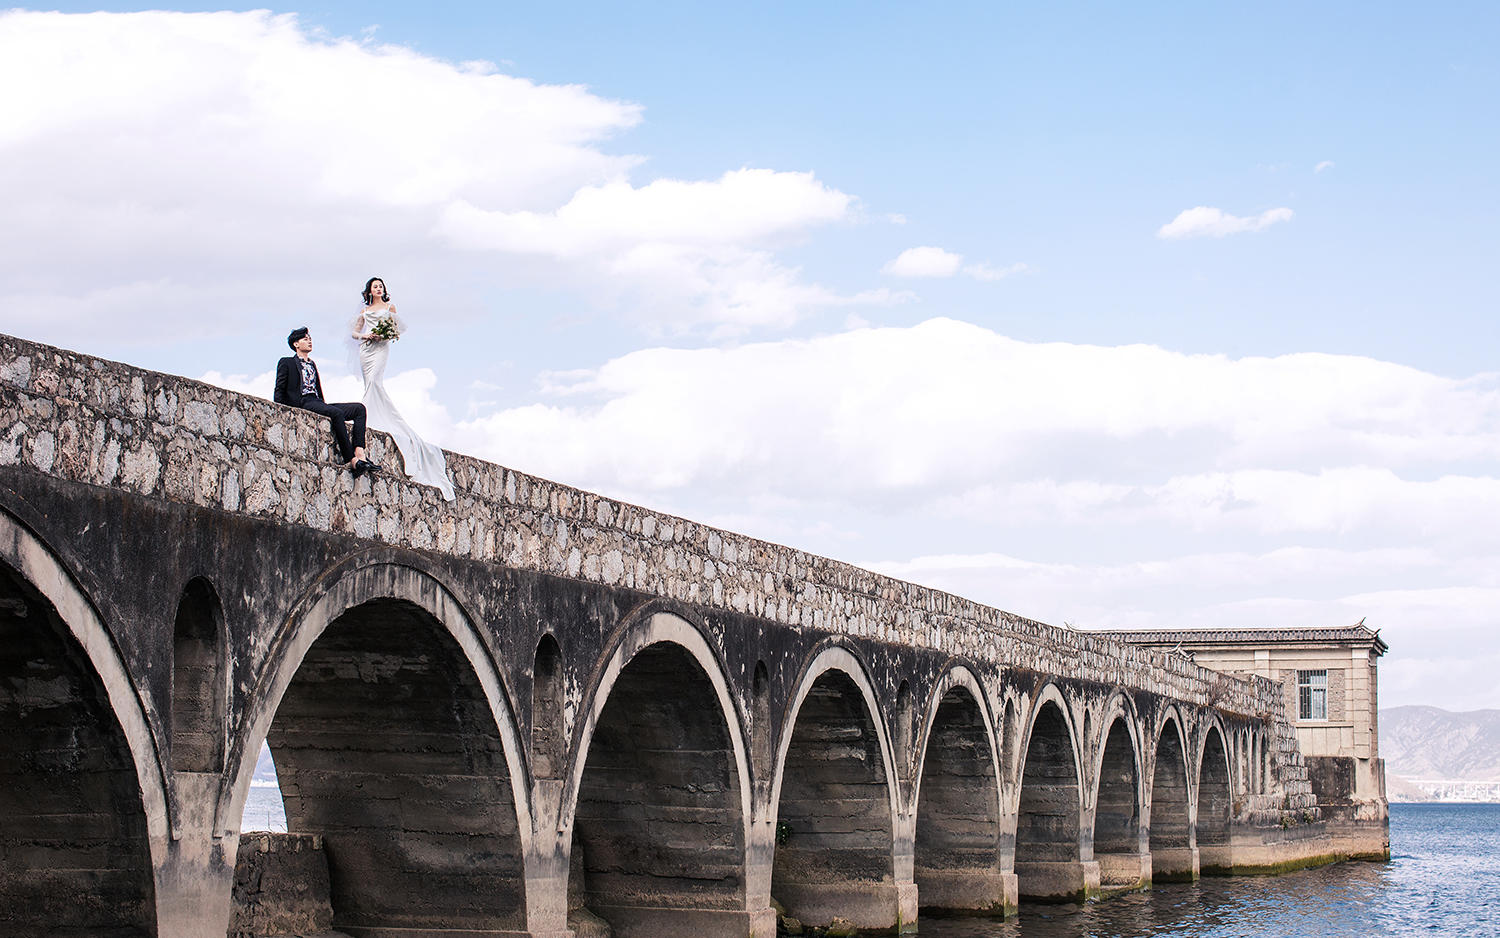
{"left": 1106, "top": 620, "right": 1391, "bottom": 858}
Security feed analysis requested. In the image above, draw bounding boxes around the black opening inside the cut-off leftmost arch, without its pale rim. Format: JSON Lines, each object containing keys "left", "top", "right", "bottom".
{"left": 0, "top": 564, "right": 156, "bottom": 938}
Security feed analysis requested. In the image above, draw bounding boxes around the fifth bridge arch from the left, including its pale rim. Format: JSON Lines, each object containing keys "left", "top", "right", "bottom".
{"left": 912, "top": 665, "right": 1007, "bottom": 914}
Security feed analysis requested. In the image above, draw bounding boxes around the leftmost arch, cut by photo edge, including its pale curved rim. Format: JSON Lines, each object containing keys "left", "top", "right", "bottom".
{"left": 0, "top": 512, "right": 168, "bottom": 936}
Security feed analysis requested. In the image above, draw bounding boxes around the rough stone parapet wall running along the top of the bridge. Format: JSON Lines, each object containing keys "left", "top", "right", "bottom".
{"left": 0, "top": 335, "right": 1284, "bottom": 719}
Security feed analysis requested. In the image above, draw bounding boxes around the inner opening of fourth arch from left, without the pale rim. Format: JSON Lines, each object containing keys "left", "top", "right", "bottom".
{"left": 771, "top": 669, "right": 894, "bottom": 927}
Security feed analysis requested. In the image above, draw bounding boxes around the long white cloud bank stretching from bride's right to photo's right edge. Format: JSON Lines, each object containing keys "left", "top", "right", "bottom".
{"left": 450, "top": 320, "right": 1500, "bottom": 513}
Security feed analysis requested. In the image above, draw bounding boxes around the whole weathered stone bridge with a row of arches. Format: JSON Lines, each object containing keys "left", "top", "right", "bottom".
{"left": 0, "top": 336, "right": 1362, "bottom": 938}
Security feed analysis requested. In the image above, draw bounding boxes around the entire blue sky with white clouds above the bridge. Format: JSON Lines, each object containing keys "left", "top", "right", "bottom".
{"left": 0, "top": 3, "right": 1500, "bottom": 708}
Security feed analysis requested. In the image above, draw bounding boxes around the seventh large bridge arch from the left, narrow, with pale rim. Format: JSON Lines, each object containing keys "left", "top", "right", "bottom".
{"left": 1094, "top": 690, "right": 1151, "bottom": 887}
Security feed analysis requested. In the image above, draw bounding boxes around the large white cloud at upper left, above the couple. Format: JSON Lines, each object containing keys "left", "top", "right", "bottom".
{"left": 0, "top": 11, "right": 899, "bottom": 341}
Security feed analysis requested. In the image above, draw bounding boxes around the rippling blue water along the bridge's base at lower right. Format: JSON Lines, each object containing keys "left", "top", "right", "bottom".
{"left": 921, "top": 804, "right": 1500, "bottom": 938}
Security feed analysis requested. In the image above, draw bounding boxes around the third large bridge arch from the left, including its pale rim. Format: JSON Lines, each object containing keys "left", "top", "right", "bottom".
{"left": 560, "top": 603, "right": 756, "bottom": 938}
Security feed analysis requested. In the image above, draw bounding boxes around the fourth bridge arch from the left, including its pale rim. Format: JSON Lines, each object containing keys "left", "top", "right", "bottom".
{"left": 771, "top": 645, "right": 894, "bottom": 929}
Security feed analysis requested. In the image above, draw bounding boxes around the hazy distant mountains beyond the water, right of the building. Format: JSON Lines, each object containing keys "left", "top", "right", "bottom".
{"left": 1380, "top": 707, "right": 1500, "bottom": 801}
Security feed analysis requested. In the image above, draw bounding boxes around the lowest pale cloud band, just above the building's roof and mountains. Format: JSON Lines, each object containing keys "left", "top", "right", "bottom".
{"left": 864, "top": 546, "right": 1500, "bottom": 710}
